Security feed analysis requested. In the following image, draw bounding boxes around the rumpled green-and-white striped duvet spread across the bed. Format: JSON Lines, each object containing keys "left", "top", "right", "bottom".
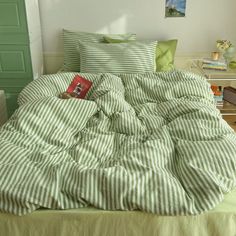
{"left": 0, "top": 71, "right": 236, "bottom": 215}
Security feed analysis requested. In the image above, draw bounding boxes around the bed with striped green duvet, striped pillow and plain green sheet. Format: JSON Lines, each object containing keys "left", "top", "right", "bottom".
{"left": 0, "top": 30, "right": 236, "bottom": 235}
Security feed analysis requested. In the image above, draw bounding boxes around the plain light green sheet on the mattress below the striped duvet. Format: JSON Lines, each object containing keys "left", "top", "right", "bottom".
{"left": 0, "top": 189, "right": 236, "bottom": 236}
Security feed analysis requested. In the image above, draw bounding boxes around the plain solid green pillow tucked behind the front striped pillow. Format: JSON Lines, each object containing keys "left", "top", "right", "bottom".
{"left": 104, "top": 36, "right": 178, "bottom": 71}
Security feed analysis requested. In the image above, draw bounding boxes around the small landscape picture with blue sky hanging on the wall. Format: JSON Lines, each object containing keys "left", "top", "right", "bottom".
{"left": 165, "top": 0, "right": 186, "bottom": 17}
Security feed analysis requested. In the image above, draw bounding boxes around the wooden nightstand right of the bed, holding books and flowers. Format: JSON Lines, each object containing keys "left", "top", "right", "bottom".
{"left": 190, "top": 60, "right": 236, "bottom": 131}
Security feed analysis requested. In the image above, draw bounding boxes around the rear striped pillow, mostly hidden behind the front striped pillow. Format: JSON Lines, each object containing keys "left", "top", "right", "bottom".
{"left": 63, "top": 29, "right": 136, "bottom": 72}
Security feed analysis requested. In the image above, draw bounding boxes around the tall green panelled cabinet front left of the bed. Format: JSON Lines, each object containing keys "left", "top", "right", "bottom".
{"left": 0, "top": 0, "right": 33, "bottom": 116}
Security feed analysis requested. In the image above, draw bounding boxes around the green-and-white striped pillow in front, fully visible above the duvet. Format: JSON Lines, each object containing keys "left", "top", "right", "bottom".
{"left": 79, "top": 41, "right": 157, "bottom": 74}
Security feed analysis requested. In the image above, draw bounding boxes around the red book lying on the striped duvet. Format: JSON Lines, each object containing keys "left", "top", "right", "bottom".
{"left": 66, "top": 75, "right": 92, "bottom": 98}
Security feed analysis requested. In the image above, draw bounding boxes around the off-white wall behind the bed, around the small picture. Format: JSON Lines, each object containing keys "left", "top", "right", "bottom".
{"left": 37, "top": 0, "right": 236, "bottom": 71}
